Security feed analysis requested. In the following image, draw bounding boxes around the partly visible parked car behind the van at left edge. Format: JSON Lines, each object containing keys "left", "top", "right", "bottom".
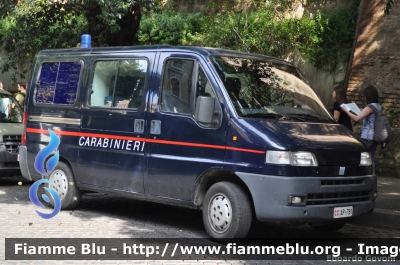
{"left": 0, "top": 90, "right": 22, "bottom": 177}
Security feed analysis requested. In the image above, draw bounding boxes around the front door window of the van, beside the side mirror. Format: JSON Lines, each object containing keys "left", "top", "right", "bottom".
{"left": 161, "top": 59, "right": 194, "bottom": 114}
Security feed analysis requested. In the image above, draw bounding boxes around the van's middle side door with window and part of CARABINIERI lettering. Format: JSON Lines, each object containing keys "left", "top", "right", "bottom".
{"left": 77, "top": 53, "right": 154, "bottom": 193}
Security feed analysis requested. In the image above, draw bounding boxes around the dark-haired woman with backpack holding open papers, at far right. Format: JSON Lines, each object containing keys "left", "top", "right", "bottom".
{"left": 341, "top": 85, "right": 382, "bottom": 173}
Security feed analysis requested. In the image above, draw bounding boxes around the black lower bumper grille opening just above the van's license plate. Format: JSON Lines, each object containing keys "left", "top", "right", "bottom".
{"left": 307, "top": 190, "right": 372, "bottom": 205}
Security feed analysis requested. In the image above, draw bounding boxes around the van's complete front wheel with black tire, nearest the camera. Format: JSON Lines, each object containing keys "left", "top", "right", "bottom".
{"left": 203, "top": 182, "right": 252, "bottom": 243}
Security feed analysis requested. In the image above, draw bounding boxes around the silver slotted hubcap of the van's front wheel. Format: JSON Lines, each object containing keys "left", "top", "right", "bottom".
{"left": 208, "top": 193, "right": 232, "bottom": 233}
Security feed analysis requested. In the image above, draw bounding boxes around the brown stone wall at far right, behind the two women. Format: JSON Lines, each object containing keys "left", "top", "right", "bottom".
{"left": 347, "top": 0, "right": 400, "bottom": 177}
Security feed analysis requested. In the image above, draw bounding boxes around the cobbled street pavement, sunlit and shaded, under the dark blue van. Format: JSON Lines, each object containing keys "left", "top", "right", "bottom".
{"left": 0, "top": 174, "right": 400, "bottom": 265}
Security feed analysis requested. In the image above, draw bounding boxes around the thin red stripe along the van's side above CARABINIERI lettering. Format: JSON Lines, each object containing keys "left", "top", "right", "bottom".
{"left": 26, "top": 128, "right": 265, "bottom": 154}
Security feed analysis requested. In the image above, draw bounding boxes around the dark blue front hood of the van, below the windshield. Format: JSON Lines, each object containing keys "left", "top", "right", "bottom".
{"left": 257, "top": 120, "right": 368, "bottom": 166}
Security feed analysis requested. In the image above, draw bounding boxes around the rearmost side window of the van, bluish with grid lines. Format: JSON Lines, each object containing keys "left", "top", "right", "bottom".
{"left": 35, "top": 62, "right": 82, "bottom": 105}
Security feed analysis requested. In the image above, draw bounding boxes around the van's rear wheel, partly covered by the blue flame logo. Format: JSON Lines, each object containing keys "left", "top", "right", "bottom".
{"left": 46, "top": 162, "right": 82, "bottom": 210}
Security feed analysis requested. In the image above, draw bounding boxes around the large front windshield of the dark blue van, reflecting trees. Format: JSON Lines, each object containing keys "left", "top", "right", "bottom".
{"left": 211, "top": 57, "right": 334, "bottom": 122}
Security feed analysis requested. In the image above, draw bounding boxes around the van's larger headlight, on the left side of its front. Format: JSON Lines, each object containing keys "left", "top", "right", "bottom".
{"left": 265, "top": 151, "right": 318, "bottom": 167}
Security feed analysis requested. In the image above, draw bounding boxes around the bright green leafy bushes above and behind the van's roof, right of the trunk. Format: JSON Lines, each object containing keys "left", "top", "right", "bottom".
{"left": 139, "top": 4, "right": 357, "bottom": 72}
